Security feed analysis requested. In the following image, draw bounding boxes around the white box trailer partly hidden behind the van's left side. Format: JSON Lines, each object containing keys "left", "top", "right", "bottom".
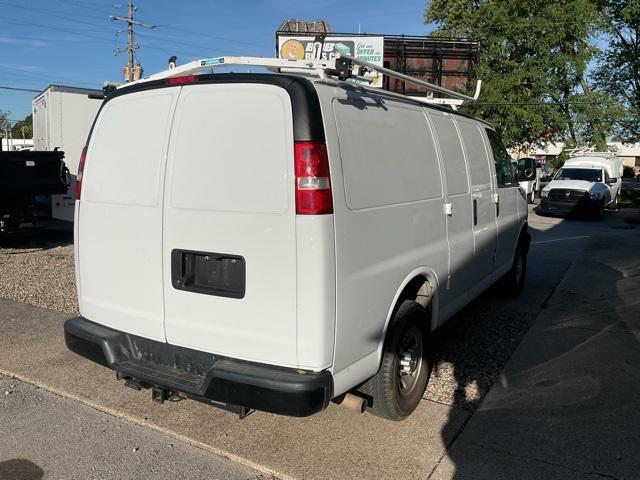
{"left": 31, "top": 85, "right": 104, "bottom": 222}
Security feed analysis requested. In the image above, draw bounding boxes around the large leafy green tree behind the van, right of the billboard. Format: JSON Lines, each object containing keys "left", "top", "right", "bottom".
{"left": 425, "top": 0, "right": 610, "bottom": 146}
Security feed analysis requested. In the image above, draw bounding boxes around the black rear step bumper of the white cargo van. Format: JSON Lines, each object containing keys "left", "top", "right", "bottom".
{"left": 64, "top": 317, "right": 333, "bottom": 417}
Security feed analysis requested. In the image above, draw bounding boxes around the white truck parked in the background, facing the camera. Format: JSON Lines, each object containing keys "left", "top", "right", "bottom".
{"left": 540, "top": 153, "right": 622, "bottom": 219}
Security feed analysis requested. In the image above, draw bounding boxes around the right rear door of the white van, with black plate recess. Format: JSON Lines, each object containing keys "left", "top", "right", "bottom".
{"left": 162, "top": 83, "right": 296, "bottom": 366}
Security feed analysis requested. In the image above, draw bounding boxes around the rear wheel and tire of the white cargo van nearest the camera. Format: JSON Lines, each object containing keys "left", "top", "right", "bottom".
{"left": 359, "top": 300, "right": 430, "bottom": 421}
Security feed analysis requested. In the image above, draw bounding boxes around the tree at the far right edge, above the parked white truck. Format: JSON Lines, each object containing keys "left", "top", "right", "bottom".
{"left": 592, "top": 0, "right": 640, "bottom": 142}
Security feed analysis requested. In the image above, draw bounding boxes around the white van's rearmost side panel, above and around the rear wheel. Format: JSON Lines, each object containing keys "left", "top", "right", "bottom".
{"left": 318, "top": 86, "right": 448, "bottom": 378}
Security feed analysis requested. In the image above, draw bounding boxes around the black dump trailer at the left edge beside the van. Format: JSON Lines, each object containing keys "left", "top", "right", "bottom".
{"left": 0, "top": 151, "right": 69, "bottom": 235}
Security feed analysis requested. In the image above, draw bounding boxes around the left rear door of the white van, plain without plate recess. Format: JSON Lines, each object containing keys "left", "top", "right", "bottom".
{"left": 75, "top": 88, "right": 178, "bottom": 341}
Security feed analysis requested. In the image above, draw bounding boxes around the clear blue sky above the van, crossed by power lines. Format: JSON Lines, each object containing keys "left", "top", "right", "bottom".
{"left": 0, "top": 0, "right": 428, "bottom": 120}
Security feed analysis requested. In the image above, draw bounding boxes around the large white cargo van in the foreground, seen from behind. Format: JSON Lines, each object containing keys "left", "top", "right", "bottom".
{"left": 65, "top": 55, "right": 529, "bottom": 420}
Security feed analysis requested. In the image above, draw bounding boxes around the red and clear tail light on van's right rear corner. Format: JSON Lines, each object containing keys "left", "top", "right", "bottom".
{"left": 294, "top": 142, "right": 333, "bottom": 215}
